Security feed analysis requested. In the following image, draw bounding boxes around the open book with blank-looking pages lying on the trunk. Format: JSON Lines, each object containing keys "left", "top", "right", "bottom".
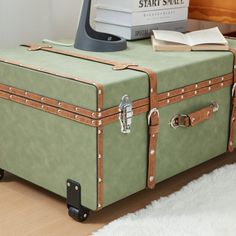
{"left": 152, "top": 27, "right": 229, "bottom": 51}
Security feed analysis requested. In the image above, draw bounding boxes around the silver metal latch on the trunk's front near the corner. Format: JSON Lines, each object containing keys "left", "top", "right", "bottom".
{"left": 119, "top": 95, "right": 134, "bottom": 134}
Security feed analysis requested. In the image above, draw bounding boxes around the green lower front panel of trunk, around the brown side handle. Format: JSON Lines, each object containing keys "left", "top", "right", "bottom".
{"left": 104, "top": 87, "right": 230, "bottom": 206}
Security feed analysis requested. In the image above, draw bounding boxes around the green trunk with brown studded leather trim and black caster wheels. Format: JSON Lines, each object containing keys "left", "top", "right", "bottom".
{"left": 0, "top": 40, "right": 236, "bottom": 221}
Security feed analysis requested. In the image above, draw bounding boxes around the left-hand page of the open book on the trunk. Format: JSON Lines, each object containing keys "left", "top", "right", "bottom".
{"left": 153, "top": 30, "right": 188, "bottom": 44}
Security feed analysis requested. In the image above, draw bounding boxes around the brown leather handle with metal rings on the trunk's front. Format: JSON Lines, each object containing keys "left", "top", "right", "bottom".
{"left": 170, "top": 102, "right": 219, "bottom": 129}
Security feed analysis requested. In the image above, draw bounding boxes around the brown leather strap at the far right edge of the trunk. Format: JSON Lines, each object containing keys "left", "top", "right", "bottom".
{"left": 228, "top": 48, "right": 236, "bottom": 152}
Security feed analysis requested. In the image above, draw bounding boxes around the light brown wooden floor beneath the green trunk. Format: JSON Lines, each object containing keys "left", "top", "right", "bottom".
{"left": 0, "top": 152, "right": 236, "bottom": 236}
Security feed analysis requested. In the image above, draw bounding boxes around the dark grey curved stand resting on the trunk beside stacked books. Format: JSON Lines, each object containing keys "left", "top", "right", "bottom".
{"left": 74, "top": 0, "right": 127, "bottom": 52}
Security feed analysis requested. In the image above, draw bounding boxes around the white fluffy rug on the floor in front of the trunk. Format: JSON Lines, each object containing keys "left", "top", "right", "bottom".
{"left": 93, "top": 164, "right": 236, "bottom": 236}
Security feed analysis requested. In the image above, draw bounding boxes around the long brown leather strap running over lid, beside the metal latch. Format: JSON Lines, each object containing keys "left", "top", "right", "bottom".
{"left": 22, "top": 44, "right": 159, "bottom": 189}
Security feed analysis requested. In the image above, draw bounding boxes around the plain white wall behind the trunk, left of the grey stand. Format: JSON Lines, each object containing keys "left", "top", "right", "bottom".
{"left": 0, "top": 0, "right": 82, "bottom": 48}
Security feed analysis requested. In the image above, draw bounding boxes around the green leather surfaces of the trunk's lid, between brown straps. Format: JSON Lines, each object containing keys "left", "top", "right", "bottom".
{"left": 0, "top": 40, "right": 233, "bottom": 109}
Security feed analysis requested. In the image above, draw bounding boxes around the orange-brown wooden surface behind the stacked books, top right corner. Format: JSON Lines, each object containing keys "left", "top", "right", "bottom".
{"left": 189, "top": 0, "right": 236, "bottom": 24}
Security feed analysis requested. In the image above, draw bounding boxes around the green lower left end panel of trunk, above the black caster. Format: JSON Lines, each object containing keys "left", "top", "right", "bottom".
{"left": 0, "top": 99, "right": 97, "bottom": 210}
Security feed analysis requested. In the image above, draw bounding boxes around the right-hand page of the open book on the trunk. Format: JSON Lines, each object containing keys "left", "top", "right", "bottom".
{"left": 186, "top": 27, "right": 228, "bottom": 46}
